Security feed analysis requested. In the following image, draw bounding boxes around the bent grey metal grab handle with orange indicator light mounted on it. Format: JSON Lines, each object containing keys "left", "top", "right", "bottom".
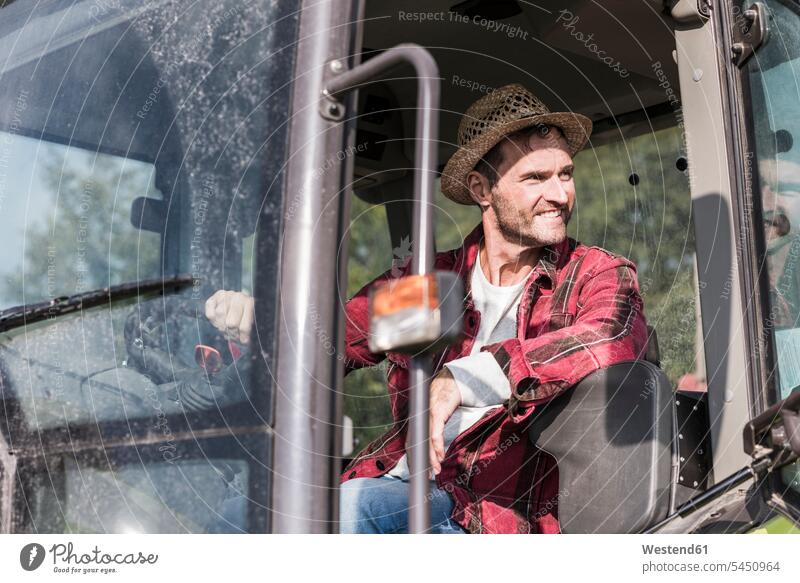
{"left": 323, "top": 44, "right": 441, "bottom": 533}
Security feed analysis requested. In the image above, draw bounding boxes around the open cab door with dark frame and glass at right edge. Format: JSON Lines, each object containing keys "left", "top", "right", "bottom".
{"left": 722, "top": 0, "right": 800, "bottom": 520}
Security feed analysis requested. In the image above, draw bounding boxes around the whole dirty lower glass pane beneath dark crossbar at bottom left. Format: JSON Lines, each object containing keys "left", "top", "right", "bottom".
{"left": 18, "top": 437, "right": 266, "bottom": 534}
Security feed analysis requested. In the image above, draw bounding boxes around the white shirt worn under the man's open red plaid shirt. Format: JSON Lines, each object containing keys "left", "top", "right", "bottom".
{"left": 388, "top": 246, "right": 527, "bottom": 480}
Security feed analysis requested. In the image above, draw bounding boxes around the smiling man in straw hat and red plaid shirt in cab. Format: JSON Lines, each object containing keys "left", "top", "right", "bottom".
{"left": 207, "top": 84, "right": 647, "bottom": 533}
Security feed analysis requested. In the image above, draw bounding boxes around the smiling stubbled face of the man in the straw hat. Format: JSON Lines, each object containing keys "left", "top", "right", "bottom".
{"left": 484, "top": 131, "right": 575, "bottom": 247}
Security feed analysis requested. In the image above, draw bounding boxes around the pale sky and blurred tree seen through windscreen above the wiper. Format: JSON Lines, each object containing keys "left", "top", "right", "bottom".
{"left": 0, "top": 132, "right": 162, "bottom": 310}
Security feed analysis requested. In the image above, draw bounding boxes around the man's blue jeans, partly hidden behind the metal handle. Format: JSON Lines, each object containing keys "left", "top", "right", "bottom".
{"left": 339, "top": 475, "right": 466, "bottom": 534}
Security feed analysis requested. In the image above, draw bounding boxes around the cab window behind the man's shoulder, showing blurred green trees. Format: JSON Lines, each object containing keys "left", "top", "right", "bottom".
{"left": 570, "top": 126, "right": 706, "bottom": 391}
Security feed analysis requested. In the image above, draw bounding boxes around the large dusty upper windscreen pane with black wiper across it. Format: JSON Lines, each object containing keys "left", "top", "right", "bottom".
{"left": 0, "top": 2, "right": 286, "bottom": 430}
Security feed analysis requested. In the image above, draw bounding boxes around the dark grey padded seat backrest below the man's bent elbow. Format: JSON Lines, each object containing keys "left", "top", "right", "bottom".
{"left": 529, "top": 360, "right": 672, "bottom": 533}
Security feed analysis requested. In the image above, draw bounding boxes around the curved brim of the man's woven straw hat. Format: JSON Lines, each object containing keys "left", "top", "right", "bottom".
{"left": 441, "top": 112, "right": 592, "bottom": 204}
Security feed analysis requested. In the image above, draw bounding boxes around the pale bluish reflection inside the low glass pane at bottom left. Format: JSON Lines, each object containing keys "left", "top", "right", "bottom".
{"left": 29, "top": 456, "right": 248, "bottom": 534}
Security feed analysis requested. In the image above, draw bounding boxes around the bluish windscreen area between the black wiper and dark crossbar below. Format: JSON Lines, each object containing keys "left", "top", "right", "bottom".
{"left": 0, "top": 295, "right": 249, "bottom": 432}
